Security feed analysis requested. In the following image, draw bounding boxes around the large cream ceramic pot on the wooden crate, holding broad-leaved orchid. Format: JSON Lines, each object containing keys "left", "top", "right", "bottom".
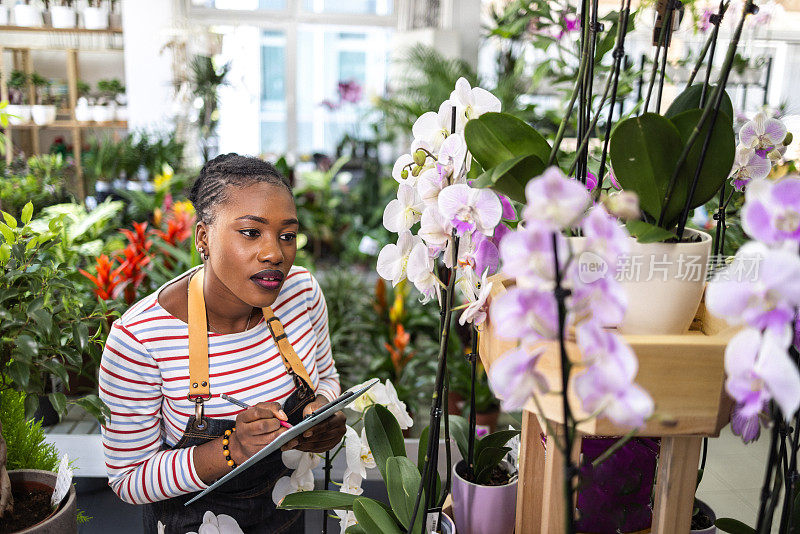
{"left": 616, "top": 229, "right": 711, "bottom": 335}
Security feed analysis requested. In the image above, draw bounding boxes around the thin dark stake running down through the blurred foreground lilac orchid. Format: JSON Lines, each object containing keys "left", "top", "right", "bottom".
{"left": 553, "top": 232, "right": 578, "bottom": 534}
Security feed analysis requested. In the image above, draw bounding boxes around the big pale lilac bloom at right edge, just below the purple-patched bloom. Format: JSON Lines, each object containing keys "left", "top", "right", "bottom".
{"left": 706, "top": 241, "right": 800, "bottom": 336}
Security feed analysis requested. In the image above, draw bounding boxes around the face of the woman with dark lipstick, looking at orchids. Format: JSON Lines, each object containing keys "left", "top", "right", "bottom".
{"left": 196, "top": 182, "right": 298, "bottom": 308}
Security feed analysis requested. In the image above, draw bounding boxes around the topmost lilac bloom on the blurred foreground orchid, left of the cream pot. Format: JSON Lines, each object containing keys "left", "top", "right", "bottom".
{"left": 522, "top": 167, "right": 592, "bottom": 229}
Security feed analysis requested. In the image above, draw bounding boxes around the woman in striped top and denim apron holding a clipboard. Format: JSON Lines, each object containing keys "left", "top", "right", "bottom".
{"left": 100, "top": 154, "right": 345, "bottom": 534}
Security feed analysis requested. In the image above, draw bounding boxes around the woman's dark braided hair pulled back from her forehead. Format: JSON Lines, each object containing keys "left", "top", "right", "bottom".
{"left": 189, "top": 153, "right": 292, "bottom": 224}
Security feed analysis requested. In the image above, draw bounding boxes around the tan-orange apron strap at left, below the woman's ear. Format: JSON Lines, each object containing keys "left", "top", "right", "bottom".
{"left": 189, "top": 267, "right": 211, "bottom": 400}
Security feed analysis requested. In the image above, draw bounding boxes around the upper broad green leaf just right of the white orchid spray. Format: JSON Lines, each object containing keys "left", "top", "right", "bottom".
{"left": 464, "top": 113, "right": 550, "bottom": 171}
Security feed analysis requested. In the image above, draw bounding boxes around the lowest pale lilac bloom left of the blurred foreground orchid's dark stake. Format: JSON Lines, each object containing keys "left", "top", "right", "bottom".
{"left": 489, "top": 347, "right": 549, "bottom": 412}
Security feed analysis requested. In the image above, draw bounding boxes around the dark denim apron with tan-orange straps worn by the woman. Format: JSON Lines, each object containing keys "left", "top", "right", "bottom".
{"left": 144, "top": 268, "right": 316, "bottom": 534}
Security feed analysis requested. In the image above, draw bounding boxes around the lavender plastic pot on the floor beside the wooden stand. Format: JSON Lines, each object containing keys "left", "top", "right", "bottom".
{"left": 453, "top": 460, "right": 517, "bottom": 534}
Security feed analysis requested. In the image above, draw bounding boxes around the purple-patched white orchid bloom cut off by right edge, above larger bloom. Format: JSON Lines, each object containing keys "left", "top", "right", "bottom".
{"left": 742, "top": 176, "right": 800, "bottom": 245}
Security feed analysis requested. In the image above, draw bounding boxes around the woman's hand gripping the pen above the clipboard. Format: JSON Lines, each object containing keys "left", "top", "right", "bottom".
{"left": 228, "top": 402, "right": 288, "bottom": 464}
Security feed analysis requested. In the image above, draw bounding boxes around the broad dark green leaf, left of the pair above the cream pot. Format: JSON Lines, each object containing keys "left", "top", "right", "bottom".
{"left": 609, "top": 113, "right": 684, "bottom": 226}
